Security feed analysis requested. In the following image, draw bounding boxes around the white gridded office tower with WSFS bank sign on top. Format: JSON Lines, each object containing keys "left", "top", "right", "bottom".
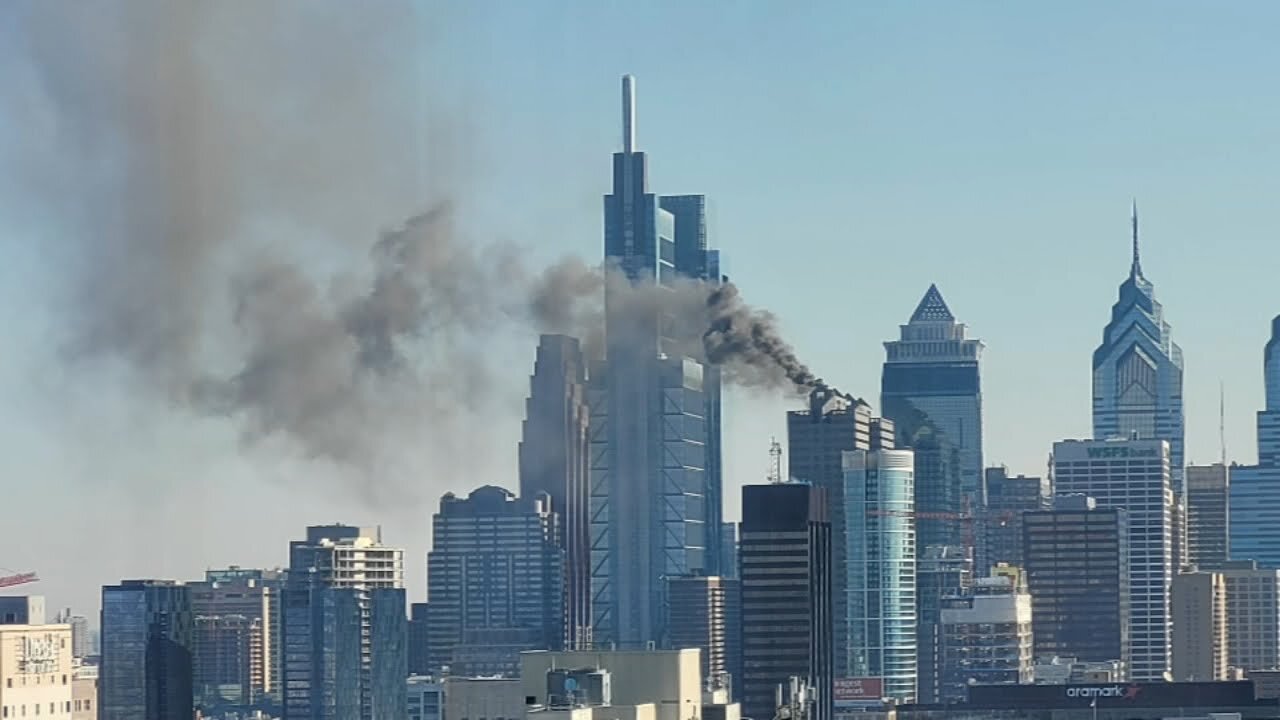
{"left": 1049, "top": 439, "right": 1174, "bottom": 682}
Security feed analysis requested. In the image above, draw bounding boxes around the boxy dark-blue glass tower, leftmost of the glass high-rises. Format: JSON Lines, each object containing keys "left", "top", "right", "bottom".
{"left": 97, "top": 580, "right": 195, "bottom": 720}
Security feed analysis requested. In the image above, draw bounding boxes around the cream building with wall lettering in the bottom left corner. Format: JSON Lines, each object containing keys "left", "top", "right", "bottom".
{"left": 0, "top": 625, "right": 74, "bottom": 720}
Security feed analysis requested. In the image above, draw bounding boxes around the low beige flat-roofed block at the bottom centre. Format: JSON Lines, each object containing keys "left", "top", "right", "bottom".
{"left": 519, "top": 648, "right": 703, "bottom": 720}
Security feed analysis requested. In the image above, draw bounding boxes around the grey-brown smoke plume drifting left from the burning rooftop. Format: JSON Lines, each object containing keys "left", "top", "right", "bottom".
{"left": 0, "top": 0, "right": 839, "bottom": 481}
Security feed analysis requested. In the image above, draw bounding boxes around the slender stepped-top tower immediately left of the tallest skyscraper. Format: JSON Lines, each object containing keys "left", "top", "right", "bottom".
{"left": 520, "top": 334, "right": 591, "bottom": 650}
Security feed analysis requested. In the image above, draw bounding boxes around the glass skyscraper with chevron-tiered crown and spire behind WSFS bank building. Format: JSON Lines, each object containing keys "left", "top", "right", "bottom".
{"left": 1093, "top": 205, "right": 1185, "bottom": 489}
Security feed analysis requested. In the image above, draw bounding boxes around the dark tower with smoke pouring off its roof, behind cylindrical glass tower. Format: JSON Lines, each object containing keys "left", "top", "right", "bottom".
{"left": 787, "top": 388, "right": 893, "bottom": 676}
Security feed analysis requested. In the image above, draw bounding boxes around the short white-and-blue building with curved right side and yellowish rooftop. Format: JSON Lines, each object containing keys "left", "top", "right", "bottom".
{"left": 940, "top": 577, "right": 1034, "bottom": 703}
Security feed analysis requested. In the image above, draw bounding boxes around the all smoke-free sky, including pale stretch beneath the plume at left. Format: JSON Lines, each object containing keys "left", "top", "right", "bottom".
{"left": 0, "top": 1, "right": 1280, "bottom": 612}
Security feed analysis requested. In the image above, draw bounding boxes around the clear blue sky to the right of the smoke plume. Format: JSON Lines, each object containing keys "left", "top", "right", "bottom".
{"left": 448, "top": 1, "right": 1280, "bottom": 471}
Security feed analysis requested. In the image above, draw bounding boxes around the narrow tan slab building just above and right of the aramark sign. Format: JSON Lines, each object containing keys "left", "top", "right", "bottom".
{"left": 1170, "top": 573, "right": 1228, "bottom": 683}
